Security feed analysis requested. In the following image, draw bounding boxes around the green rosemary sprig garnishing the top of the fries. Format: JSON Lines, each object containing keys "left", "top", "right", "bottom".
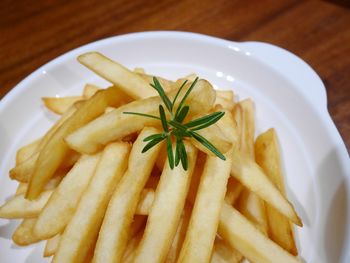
{"left": 123, "top": 77, "right": 226, "bottom": 170}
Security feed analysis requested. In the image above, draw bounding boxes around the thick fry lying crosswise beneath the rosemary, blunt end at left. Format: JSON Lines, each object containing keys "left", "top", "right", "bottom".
{"left": 66, "top": 80, "right": 219, "bottom": 156}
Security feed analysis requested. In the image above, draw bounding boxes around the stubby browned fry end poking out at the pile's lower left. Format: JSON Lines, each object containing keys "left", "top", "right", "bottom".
{"left": 12, "top": 218, "right": 41, "bottom": 246}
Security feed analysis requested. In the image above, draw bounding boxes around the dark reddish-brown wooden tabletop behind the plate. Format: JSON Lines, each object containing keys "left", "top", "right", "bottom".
{"left": 0, "top": 0, "right": 350, "bottom": 153}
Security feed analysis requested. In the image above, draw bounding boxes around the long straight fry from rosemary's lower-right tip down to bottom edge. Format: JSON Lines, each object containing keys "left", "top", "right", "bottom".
{"left": 178, "top": 152, "right": 232, "bottom": 262}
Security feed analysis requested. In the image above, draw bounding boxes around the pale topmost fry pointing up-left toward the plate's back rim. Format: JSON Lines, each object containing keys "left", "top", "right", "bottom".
{"left": 78, "top": 52, "right": 157, "bottom": 99}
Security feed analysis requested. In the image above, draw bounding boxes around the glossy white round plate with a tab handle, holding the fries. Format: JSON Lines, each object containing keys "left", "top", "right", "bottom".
{"left": 0, "top": 32, "right": 350, "bottom": 263}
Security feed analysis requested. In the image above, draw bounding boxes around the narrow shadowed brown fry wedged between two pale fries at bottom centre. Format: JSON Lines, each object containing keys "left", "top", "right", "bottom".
{"left": 165, "top": 206, "right": 193, "bottom": 263}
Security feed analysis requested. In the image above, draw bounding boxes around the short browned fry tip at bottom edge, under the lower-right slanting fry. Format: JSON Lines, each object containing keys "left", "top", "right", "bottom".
{"left": 210, "top": 238, "right": 242, "bottom": 263}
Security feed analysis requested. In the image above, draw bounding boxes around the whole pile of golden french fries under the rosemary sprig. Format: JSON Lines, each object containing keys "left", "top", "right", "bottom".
{"left": 0, "top": 52, "right": 302, "bottom": 263}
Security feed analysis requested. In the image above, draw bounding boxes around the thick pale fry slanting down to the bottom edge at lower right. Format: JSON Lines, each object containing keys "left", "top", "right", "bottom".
{"left": 218, "top": 204, "right": 301, "bottom": 263}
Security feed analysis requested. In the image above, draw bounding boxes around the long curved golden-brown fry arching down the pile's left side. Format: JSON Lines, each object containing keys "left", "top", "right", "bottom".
{"left": 26, "top": 87, "right": 121, "bottom": 199}
